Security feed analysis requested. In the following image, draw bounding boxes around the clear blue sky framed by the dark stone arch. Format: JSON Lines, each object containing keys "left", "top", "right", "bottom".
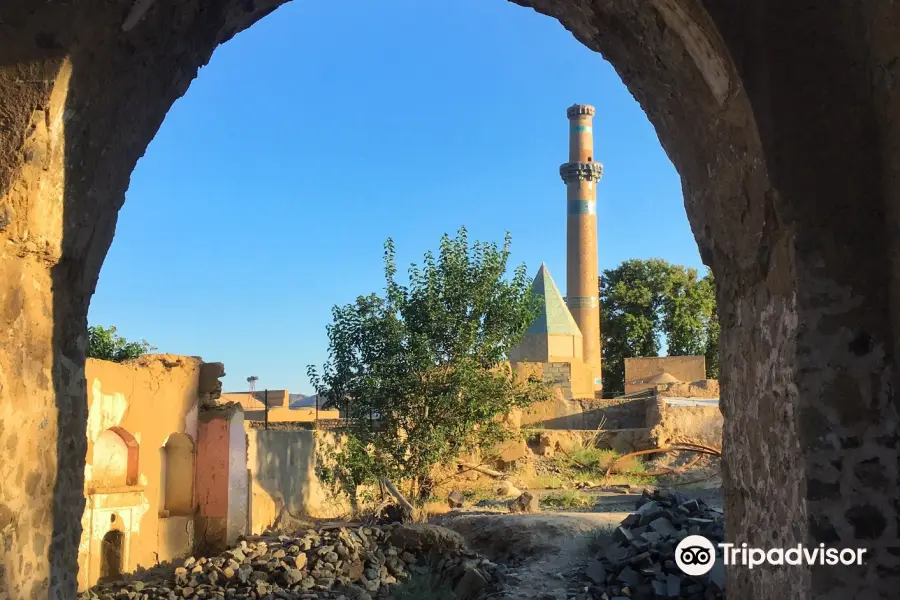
{"left": 90, "top": 0, "right": 702, "bottom": 393}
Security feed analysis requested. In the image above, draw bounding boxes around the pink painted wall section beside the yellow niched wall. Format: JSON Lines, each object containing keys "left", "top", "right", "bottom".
{"left": 195, "top": 413, "right": 231, "bottom": 519}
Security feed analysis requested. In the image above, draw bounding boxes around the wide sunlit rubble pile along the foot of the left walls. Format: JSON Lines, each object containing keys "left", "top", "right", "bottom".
{"left": 79, "top": 524, "right": 504, "bottom": 600}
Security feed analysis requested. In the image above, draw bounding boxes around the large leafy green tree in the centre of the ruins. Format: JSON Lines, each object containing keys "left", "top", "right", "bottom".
{"left": 308, "top": 228, "right": 547, "bottom": 499}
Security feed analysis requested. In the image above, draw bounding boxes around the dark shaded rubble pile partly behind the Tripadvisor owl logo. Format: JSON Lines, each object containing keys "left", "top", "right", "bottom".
{"left": 573, "top": 490, "right": 725, "bottom": 600}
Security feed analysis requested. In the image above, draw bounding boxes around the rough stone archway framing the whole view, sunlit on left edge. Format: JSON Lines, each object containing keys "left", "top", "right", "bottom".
{"left": 0, "top": 0, "right": 900, "bottom": 600}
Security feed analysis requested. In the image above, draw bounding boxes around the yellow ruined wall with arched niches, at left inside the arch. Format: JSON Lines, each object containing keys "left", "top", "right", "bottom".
{"left": 78, "top": 355, "right": 203, "bottom": 589}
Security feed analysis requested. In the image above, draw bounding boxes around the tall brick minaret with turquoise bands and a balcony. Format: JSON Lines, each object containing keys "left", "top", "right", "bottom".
{"left": 559, "top": 104, "right": 603, "bottom": 390}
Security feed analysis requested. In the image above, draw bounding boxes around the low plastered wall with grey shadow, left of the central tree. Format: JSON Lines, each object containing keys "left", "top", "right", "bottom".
{"left": 247, "top": 427, "right": 350, "bottom": 533}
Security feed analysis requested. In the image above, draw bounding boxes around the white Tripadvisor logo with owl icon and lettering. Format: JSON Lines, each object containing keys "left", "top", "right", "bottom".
{"left": 675, "top": 535, "right": 866, "bottom": 577}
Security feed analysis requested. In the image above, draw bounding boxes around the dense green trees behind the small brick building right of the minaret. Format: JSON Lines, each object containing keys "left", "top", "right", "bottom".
{"left": 599, "top": 258, "right": 719, "bottom": 392}
